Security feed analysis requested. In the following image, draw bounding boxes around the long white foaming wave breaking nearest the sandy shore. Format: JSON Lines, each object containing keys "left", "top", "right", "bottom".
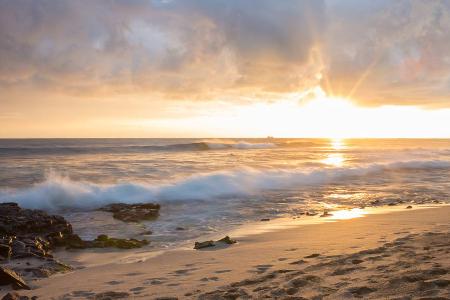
{"left": 0, "top": 160, "right": 450, "bottom": 211}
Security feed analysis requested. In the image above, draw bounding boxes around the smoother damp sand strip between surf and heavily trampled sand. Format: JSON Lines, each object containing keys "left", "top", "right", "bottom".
{"left": 4, "top": 205, "right": 450, "bottom": 299}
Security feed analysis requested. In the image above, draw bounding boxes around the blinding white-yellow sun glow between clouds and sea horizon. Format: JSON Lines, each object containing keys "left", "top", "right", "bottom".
{"left": 124, "top": 88, "right": 450, "bottom": 139}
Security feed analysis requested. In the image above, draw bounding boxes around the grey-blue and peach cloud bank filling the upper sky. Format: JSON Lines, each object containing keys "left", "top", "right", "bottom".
{"left": 0, "top": 0, "right": 450, "bottom": 106}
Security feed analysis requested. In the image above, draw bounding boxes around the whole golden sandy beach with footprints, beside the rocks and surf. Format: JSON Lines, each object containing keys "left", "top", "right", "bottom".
{"left": 3, "top": 206, "right": 450, "bottom": 299}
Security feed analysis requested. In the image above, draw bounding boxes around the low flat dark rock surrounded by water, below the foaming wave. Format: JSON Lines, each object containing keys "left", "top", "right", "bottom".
{"left": 99, "top": 203, "right": 160, "bottom": 222}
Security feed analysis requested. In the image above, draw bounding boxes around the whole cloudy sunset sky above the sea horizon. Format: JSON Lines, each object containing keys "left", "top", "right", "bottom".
{"left": 0, "top": 0, "right": 450, "bottom": 138}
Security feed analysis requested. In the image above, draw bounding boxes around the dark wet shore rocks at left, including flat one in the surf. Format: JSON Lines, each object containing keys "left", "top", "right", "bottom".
{"left": 0, "top": 202, "right": 159, "bottom": 289}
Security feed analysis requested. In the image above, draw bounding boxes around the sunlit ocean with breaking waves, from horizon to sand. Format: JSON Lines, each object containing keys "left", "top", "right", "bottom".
{"left": 0, "top": 138, "right": 450, "bottom": 249}
